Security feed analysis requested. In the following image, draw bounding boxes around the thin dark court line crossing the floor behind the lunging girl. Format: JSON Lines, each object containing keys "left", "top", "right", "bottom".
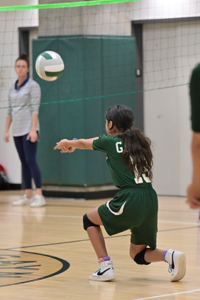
{"left": 3, "top": 225, "right": 200, "bottom": 250}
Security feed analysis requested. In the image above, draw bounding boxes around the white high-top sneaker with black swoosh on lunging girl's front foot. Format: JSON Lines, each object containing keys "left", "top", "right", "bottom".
{"left": 89, "top": 260, "right": 115, "bottom": 281}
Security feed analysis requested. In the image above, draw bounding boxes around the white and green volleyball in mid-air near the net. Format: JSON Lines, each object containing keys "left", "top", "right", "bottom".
{"left": 35, "top": 51, "right": 65, "bottom": 81}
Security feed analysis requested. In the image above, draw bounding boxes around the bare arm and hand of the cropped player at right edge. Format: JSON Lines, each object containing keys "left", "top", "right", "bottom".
{"left": 187, "top": 132, "right": 200, "bottom": 209}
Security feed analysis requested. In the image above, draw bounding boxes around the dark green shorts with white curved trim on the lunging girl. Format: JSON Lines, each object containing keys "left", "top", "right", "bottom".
{"left": 98, "top": 187, "right": 158, "bottom": 249}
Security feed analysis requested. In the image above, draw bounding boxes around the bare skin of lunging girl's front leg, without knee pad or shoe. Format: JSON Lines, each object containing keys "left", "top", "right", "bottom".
{"left": 87, "top": 207, "right": 108, "bottom": 258}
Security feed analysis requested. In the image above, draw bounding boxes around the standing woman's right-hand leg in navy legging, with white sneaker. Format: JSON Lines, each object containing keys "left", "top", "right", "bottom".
{"left": 23, "top": 135, "right": 46, "bottom": 207}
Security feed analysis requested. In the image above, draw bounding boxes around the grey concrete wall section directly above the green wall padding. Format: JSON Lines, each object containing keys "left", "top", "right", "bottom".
{"left": 39, "top": 0, "right": 131, "bottom": 36}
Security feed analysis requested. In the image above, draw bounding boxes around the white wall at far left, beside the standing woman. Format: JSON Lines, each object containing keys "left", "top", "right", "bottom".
{"left": 0, "top": 0, "right": 38, "bottom": 183}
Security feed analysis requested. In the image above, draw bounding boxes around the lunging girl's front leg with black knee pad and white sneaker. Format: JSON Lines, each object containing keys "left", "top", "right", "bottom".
{"left": 83, "top": 208, "right": 115, "bottom": 281}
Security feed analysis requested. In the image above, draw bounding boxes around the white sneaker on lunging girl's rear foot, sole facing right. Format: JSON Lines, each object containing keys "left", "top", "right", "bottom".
{"left": 165, "top": 249, "right": 186, "bottom": 281}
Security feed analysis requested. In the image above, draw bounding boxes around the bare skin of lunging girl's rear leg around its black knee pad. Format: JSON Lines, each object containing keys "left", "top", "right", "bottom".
{"left": 130, "top": 243, "right": 164, "bottom": 262}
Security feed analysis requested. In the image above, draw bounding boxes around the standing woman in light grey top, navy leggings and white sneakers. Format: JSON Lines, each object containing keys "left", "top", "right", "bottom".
{"left": 4, "top": 54, "right": 46, "bottom": 207}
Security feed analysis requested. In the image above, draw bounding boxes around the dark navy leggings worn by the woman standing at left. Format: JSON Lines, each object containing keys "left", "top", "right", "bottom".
{"left": 14, "top": 134, "right": 41, "bottom": 189}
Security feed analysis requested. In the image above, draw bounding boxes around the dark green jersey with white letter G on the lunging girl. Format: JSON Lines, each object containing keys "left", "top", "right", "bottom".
{"left": 93, "top": 135, "right": 151, "bottom": 188}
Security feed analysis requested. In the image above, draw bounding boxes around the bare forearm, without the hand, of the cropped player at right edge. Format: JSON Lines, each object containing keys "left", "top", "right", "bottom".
{"left": 192, "top": 133, "right": 200, "bottom": 198}
